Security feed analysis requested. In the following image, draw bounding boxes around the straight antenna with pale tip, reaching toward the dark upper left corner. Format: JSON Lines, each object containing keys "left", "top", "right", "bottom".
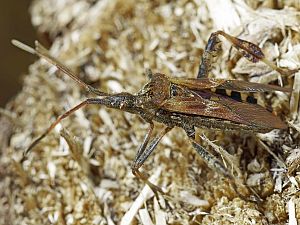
{"left": 12, "top": 40, "right": 109, "bottom": 96}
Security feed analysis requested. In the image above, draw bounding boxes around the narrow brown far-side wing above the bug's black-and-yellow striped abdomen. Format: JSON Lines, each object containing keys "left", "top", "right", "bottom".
{"left": 170, "top": 78, "right": 292, "bottom": 92}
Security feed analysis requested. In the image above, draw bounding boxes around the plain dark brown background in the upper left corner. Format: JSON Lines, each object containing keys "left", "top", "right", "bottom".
{"left": 0, "top": 0, "right": 36, "bottom": 107}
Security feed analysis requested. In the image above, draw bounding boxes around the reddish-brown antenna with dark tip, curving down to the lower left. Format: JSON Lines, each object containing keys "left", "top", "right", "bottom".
{"left": 24, "top": 98, "right": 101, "bottom": 155}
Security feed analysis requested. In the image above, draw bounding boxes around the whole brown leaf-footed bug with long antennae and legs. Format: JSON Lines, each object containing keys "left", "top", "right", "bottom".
{"left": 12, "top": 31, "right": 297, "bottom": 195}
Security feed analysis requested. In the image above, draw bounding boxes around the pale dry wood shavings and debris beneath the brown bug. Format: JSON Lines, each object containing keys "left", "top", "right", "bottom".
{"left": 0, "top": 0, "right": 300, "bottom": 224}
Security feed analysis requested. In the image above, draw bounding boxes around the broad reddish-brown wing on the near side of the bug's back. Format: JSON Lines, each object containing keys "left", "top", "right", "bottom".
{"left": 162, "top": 92, "right": 286, "bottom": 129}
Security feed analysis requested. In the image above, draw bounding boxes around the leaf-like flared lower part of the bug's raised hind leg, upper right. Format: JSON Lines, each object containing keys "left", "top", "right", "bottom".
{"left": 211, "top": 31, "right": 299, "bottom": 75}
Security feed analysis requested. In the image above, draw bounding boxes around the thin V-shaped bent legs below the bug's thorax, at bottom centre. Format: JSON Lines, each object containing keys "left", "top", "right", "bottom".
{"left": 131, "top": 124, "right": 172, "bottom": 194}
